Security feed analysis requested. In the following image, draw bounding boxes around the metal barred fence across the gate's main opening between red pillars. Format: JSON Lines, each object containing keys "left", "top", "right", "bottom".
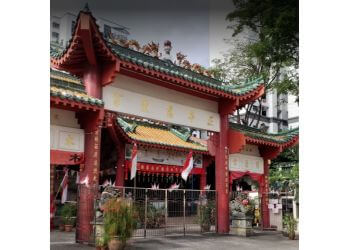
{"left": 93, "top": 187, "right": 216, "bottom": 241}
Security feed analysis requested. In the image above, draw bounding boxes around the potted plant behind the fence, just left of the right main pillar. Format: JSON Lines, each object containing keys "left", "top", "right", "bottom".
{"left": 198, "top": 197, "right": 215, "bottom": 232}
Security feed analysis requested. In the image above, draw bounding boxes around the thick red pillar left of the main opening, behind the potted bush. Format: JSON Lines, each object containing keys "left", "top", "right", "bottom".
{"left": 76, "top": 67, "right": 103, "bottom": 242}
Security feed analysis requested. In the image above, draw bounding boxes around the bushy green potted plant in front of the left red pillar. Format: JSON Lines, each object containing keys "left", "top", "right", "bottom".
{"left": 103, "top": 198, "right": 136, "bottom": 250}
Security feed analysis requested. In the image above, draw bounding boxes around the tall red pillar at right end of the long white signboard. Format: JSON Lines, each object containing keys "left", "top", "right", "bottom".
{"left": 215, "top": 114, "right": 230, "bottom": 233}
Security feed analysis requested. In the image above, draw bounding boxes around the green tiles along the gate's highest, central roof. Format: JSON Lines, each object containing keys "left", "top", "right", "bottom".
{"left": 50, "top": 6, "right": 263, "bottom": 100}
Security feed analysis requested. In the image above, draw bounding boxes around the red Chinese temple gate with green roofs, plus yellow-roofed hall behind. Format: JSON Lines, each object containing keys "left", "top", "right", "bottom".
{"left": 50, "top": 5, "right": 298, "bottom": 240}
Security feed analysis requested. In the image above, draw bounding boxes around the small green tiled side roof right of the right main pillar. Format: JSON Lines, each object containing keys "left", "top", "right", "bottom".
{"left": 230, "top": 123, "right": 299, "bottom": 144}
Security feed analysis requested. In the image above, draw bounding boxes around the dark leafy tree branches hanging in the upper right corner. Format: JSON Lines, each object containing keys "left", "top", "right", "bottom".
{"left": 227, "top": 0, "right": 299, "bottom": 95}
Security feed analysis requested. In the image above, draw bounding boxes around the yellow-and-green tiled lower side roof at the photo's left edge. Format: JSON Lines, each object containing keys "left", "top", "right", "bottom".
{"left": 50, "top": 68, "right": 104, "bottom": 107}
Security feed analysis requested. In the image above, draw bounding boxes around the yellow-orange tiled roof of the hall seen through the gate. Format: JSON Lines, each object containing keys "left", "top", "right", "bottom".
{"left": 117, "top": 117, "right": 208, "bottom": 152}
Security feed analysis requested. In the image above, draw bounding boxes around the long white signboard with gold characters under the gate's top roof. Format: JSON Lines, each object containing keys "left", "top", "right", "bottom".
{"left": 103, "top": 75, "right": 220, "bottom": 132}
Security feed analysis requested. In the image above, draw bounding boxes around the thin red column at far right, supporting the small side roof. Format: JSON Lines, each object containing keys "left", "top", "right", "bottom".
{"left": 260, "top": 158, "right": 270, "bottom": 228}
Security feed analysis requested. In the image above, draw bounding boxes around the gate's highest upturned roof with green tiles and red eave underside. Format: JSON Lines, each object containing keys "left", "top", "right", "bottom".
{"left": 50, "top": 7, "right": 264, "bottom": 108}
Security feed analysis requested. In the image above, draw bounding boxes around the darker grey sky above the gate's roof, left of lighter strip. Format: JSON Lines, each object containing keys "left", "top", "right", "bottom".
{"left": 51, "top": 0, "right": 216, "bottom": 67}
